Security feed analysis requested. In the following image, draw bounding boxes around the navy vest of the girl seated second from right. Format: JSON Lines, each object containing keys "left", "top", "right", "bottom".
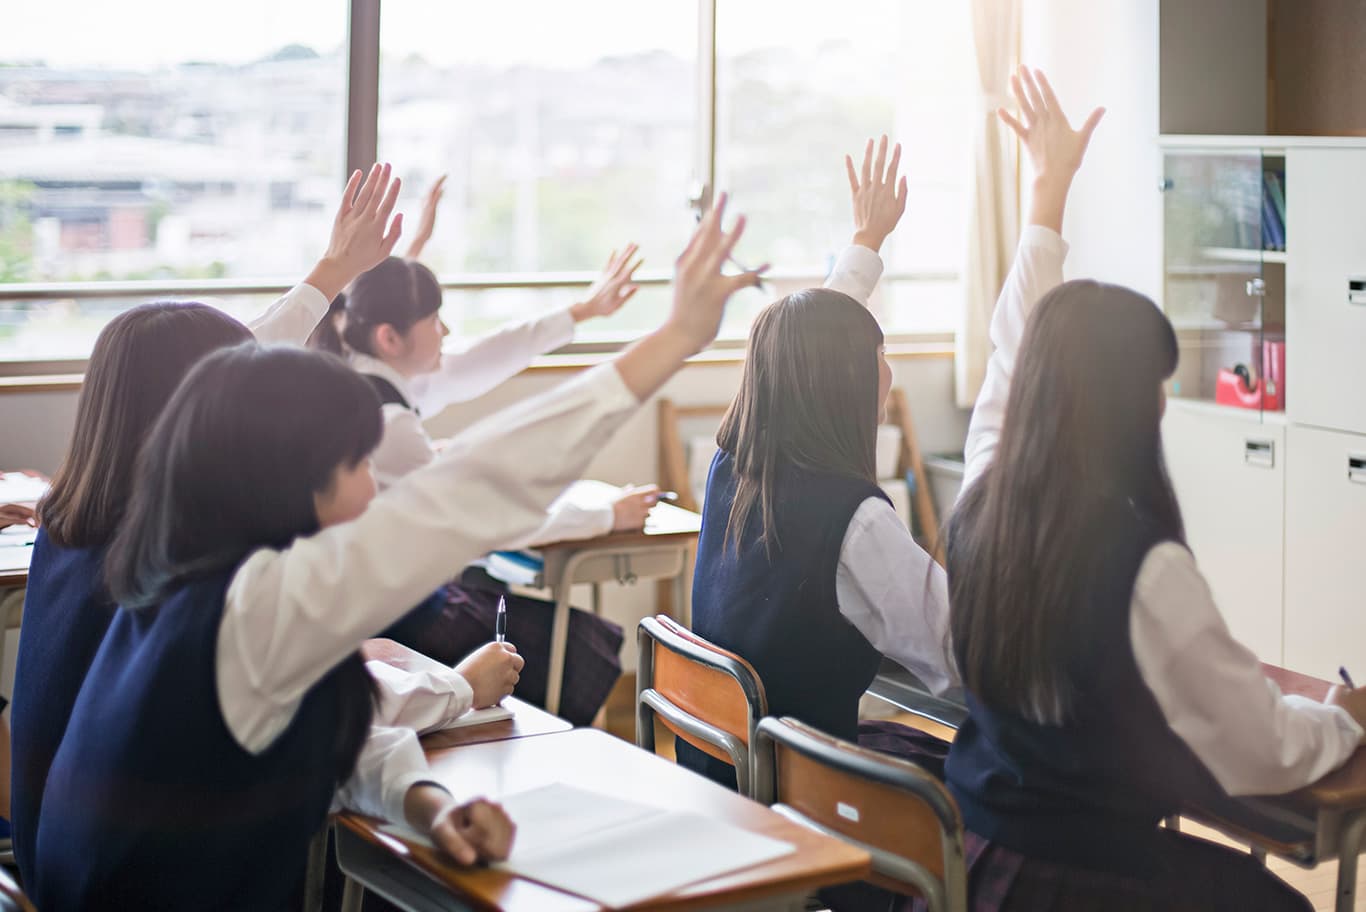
{"left": 678, "top": 451, "right": 887, "bottom": 788}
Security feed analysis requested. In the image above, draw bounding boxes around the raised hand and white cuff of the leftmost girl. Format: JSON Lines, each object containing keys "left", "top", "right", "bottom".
{"left": 247, "top": 164, "right": 403, "bottom": 345}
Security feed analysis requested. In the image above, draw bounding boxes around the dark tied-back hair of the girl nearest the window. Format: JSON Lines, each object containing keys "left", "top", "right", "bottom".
{"left": 309, "top": 257, "right": 441, "bottom": 355}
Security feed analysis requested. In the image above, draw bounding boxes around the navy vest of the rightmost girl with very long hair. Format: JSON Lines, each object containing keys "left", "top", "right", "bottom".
{"left": 945, "top": 509, "right": 1224, "bottom": 877}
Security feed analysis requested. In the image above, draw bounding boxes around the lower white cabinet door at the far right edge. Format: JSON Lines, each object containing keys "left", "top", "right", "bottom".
{"left": 1285, "top": 425, "right": 1366, "bottom": 680}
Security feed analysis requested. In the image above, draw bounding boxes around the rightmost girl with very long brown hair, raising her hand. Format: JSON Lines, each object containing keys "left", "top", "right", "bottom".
{"left": 947, "top": 68, "right": 1366, "bottom": 911}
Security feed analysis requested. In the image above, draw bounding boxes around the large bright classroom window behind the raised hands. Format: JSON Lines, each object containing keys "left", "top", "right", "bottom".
{"left": 0, "top": 0, "right": 977, "bottom": 371}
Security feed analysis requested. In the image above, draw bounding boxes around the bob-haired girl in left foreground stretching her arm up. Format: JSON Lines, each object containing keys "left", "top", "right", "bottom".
{"left": 27, "top": 201, "right": 757, "bottom": 912}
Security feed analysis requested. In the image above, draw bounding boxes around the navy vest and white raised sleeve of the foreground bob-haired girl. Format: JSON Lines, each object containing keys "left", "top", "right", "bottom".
{"left": 31, "top": 365, "right": 639, "bottom": 912}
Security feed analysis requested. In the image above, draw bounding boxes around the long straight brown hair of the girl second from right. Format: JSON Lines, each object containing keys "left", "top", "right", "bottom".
{"left": 716, "top": 288, "right": 882, "bottom": 558}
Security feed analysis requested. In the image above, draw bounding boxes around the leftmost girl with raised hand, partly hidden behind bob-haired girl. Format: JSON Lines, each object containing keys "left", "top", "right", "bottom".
{"left": 5, "top": 165, "right": 520, "bottom": 879}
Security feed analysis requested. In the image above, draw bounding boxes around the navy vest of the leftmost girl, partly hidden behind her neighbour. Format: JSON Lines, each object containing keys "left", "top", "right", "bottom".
{"left": 10, "top": 530, "right": 115, "bottom": 883}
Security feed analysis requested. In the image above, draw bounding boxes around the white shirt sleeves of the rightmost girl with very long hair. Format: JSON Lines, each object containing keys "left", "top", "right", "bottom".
{"left": 963, "top": 225, "right": 1362, "bottom": 795}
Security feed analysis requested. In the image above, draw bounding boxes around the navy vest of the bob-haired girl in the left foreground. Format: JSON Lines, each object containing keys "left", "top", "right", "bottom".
{"left": 33, "top": 571, "right": 363, "bottom": 912}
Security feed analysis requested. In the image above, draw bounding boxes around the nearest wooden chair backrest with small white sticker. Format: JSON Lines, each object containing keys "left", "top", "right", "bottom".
{"left": 753, "top": 717, "right": 967, "bottom": 912}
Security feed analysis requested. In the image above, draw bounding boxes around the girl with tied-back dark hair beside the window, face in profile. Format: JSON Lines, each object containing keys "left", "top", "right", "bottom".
{"left": 309, "top": 187, "right": 658, "bottom": 725}
